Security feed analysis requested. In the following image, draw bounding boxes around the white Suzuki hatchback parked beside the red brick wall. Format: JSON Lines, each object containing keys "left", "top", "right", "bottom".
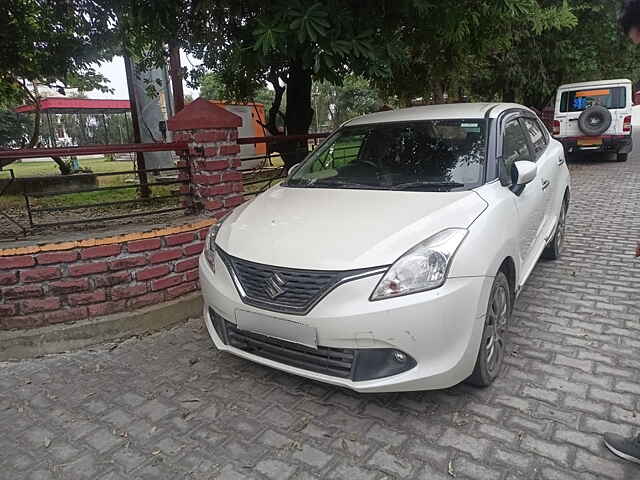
{"left": 200, "top": 103, "right": 569, "bottom": 392}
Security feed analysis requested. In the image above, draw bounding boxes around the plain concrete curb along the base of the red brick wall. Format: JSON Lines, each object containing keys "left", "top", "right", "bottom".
{"left": 0, "top": 292, "right": 202, "bottom": 361}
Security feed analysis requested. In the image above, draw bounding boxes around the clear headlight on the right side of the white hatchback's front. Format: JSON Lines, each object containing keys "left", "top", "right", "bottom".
{"left": 371, "top": 228, "right": 467, "bottom": 300}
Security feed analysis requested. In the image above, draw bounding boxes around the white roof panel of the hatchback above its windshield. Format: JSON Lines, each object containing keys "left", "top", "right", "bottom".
{"left": 345, "top": 103, "right": 530, "bottom": 126}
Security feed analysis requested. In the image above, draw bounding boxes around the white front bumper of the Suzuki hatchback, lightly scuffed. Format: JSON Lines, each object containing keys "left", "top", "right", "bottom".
{"left": 200, "top": 256, "right": 493, "bottom": 392}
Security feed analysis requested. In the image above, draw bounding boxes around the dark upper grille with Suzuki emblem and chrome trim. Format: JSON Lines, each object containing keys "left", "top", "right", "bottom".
{"left": 218, "top": 250, "right": 381, "bottom": 315}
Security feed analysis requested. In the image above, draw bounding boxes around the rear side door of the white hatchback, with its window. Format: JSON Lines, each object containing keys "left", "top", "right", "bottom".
{"left": 520, "top": 116, "right": 564, "bottom": 243}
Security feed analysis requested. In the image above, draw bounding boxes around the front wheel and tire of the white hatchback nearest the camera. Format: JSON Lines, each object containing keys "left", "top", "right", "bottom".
{"left": 467, "top": 271, "right": 512, "bottom": 387}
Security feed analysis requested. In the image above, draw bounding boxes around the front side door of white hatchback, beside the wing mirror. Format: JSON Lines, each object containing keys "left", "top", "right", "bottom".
{"left": 502, "top": 115, "right": 545, "bottom": 284}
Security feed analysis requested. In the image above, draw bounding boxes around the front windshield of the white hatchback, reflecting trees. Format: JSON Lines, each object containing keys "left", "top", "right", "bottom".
{"left": 286, "top": 119, "right": 486, "bottom": 191}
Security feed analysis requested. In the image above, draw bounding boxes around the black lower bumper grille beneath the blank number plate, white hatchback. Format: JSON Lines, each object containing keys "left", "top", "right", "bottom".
{"left": 223, "top": 320, "right": 355, "bottom": 378}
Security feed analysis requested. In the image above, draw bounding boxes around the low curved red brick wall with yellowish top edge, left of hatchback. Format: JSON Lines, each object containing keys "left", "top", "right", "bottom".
{"left": 0, "top": 221, "right": 212, "bottom": 330}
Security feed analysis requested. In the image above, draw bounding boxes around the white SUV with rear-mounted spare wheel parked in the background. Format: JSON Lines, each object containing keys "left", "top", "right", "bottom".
{"left": 553, "top": 80, "right": 633, "bottom": 162}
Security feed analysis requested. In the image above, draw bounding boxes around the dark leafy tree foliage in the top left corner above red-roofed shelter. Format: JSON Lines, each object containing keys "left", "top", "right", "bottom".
{"left": 0, "top": 0, "right": 115, "bottom": 101}
